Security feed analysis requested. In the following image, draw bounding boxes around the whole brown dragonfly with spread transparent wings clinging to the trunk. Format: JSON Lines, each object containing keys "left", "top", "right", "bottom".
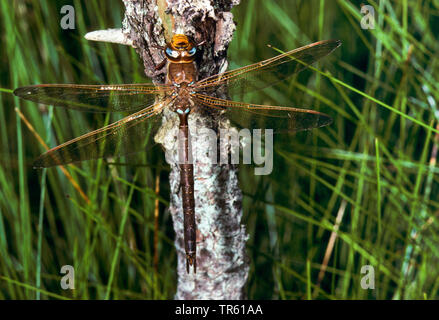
{"left": 14, "top": 34, "right": 341, "bottom": 273}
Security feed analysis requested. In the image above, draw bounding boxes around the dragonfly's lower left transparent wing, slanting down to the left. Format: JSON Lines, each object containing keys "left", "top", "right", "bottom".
{"left": 33, "top": 101, "right": 169, "bottom": 168}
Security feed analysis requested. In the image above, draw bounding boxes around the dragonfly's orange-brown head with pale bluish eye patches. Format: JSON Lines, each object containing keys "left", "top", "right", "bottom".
{"left": 165, "top": 34, "right": 197, "bottom": 63}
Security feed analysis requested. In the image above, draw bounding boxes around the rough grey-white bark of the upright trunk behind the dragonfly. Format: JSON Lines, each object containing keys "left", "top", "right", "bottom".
{"left": 122, "top": 0, "right": 249, "bottom": 299}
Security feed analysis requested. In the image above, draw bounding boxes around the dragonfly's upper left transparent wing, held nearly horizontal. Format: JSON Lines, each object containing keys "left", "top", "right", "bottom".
{"left": 14, "top": 84, "right": 172, "bottom": 112}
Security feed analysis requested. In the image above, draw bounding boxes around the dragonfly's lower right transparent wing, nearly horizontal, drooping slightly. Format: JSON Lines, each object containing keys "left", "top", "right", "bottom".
{"left": 193, "top": 94, "right": 332, "bottom": 133}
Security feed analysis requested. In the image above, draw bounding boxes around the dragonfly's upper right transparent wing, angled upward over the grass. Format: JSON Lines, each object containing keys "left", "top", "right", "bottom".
{"left": 195, "top": 40, "right": 341, "bottom": 95}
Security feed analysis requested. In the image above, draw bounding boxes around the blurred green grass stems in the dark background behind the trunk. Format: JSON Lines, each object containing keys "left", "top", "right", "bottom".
{"left": 0, "top": 0, "right": 439, "bottom": 299}
